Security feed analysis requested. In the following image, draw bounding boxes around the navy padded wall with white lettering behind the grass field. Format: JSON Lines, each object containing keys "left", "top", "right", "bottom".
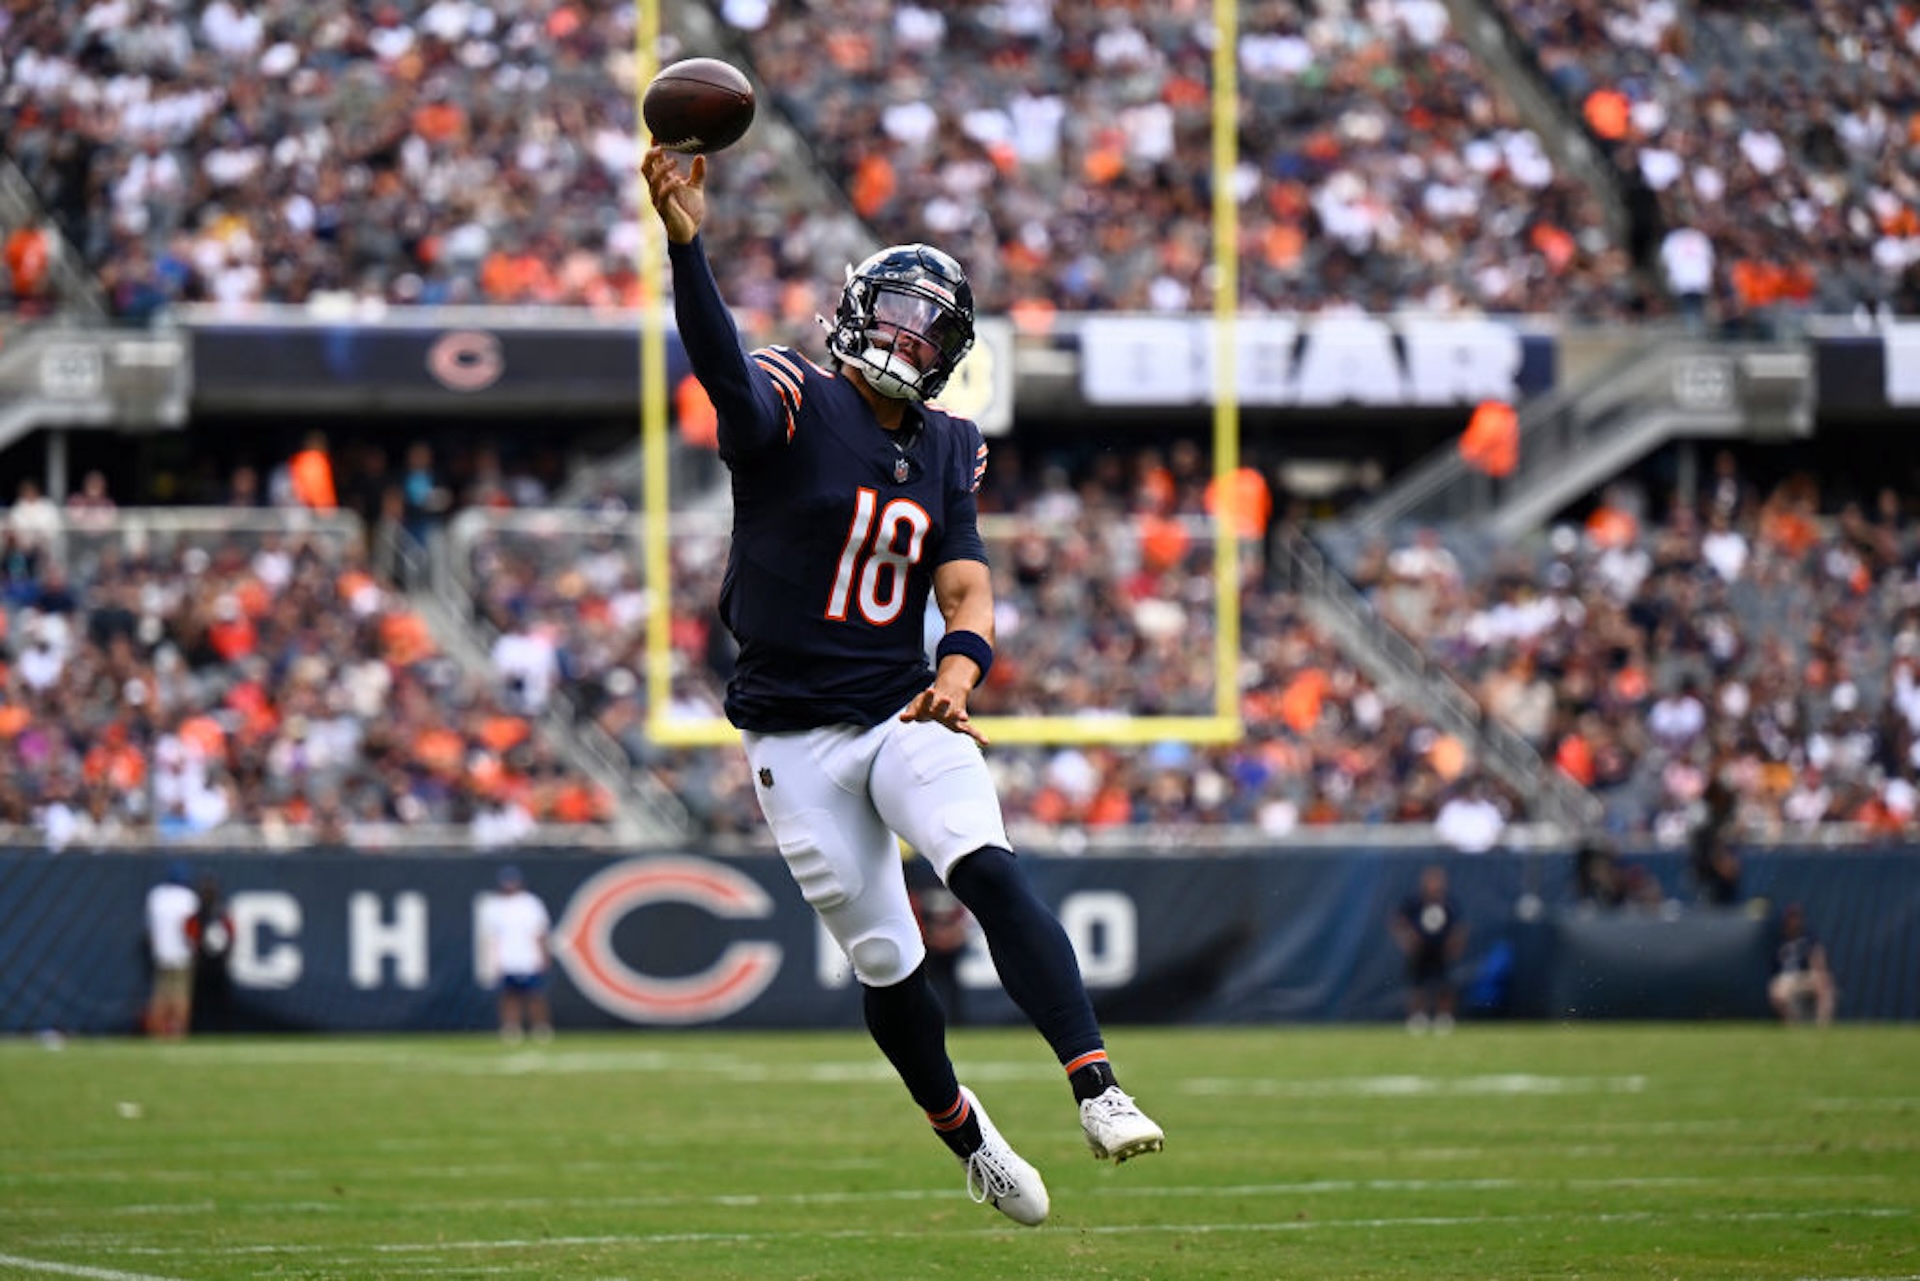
{"left": 0, "top": 849, "right": 1920, "bottom": 1033}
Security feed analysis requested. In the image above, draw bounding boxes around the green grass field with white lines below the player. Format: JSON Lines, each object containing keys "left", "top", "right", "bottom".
{"left": 0, "top": 1024, "right": 1920, "bottom": 1279}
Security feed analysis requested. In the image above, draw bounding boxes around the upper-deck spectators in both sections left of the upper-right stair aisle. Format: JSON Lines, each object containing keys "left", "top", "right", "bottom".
{"left": 0, "top": 0, "right": 1628, "bottom": 328}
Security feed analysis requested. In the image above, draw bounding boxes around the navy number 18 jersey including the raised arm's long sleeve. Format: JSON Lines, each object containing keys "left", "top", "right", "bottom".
{"left": 668, "top": 238, "right": 987, "bottom": 734}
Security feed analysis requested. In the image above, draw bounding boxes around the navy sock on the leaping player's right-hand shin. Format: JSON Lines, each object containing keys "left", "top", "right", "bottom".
{"left": 947, "top": 845, "right": 1104, "bottom": 1064}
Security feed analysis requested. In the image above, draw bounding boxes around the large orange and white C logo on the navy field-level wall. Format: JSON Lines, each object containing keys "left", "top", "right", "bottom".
{"left": 555, "top": 858, "right": 781, "bottom": 1024}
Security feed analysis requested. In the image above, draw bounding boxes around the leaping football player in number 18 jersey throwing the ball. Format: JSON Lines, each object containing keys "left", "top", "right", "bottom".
{"left": 641, "top": 146, "right": 1164, "bottom": 1225}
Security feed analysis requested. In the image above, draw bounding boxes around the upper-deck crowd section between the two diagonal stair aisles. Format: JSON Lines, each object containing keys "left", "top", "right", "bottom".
{"left": 722, "top": 0, "right": 1636, "bottom": 321}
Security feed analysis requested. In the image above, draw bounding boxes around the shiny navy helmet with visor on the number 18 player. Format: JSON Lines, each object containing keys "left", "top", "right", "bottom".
{"left": 828, "top": 244, "right": 973, "bottom": 399}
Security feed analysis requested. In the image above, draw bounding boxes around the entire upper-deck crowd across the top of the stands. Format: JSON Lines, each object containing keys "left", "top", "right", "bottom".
{"left": 0, "top": 0, "right": 1920, "bottom": 336}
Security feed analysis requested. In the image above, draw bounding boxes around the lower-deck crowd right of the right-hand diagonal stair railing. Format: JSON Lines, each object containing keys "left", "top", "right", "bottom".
{"left": 1356, "top": 455, "right": 1920, "bottom": 845}
